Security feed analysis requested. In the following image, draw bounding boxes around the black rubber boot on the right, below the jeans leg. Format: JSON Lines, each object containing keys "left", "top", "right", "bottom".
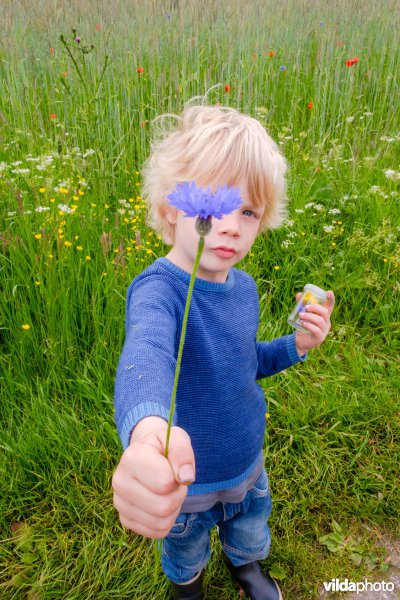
{"left": 224, "top": 555, "right": 283, "bottom": 600}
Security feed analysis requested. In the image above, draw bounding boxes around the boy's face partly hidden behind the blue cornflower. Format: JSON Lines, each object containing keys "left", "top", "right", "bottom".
{"left": 167, "top": 180, "right": 264, "bottom": 283}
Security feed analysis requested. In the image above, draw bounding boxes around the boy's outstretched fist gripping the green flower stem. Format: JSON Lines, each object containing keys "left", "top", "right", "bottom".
{"left": 112, "top": 417, "right": 195, "bottom": 538}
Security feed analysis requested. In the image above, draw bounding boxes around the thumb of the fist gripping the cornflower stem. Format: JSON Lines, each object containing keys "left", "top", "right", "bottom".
{"left": 168, "top": 427, "right": 196, "bottom": 485}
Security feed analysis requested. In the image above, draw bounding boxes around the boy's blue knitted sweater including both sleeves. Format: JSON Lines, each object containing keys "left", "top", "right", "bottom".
{"left": 115, "top": 258, "right": 303, "bottom": 494}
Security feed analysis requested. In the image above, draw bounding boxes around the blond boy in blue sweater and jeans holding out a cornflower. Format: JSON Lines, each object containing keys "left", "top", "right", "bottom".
{"left": 113, "top": 106, "right": 334, "bottom": 600}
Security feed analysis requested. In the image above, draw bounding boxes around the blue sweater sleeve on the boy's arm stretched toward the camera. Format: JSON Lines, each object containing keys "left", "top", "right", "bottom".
{"left": 114, "top": 279, "right": 178, "bottom": 450}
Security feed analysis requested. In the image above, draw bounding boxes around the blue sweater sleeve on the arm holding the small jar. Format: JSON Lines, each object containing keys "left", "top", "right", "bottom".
{"left": 256, "top": 333, "right": 307, "bottom": 379}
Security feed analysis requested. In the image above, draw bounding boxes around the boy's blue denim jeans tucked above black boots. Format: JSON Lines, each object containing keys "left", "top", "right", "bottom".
{"left": 162, "top": 470, "right": 272, "bottom": 584}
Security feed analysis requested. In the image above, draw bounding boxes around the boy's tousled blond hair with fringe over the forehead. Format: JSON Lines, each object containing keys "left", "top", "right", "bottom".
{"left": 142, "top": 105, "right": 286, "bottom": 244}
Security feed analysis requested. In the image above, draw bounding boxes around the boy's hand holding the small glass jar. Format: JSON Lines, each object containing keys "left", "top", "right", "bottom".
{"left": 296, "top": 290, "right": 335, "bottom": 356}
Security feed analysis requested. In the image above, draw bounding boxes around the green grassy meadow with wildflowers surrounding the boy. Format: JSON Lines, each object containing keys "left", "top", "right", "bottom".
{"left": 0, "top": 0, "right": 400, "bottom": 600}
